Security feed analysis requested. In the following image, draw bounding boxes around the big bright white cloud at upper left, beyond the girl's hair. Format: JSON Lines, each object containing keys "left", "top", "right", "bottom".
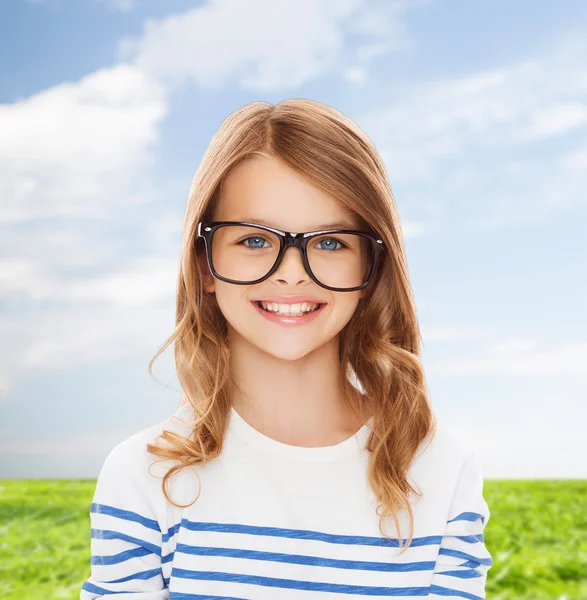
{"left": 0, "top": 65, "right": 166, "bottom": 224}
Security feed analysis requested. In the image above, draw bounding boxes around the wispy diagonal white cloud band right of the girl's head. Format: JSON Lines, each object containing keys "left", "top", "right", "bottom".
{"left": 357, "top": 35, "right": 587, "bottom": 183}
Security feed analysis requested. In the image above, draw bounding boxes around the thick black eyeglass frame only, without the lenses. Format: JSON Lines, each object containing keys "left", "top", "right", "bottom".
{"left": 196, "top": 221, "right": 385, "bottom": 292}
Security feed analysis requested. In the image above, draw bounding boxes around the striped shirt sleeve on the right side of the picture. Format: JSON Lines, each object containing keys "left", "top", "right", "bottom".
{"left": 429, "top": 452, "right": 493, "bottom": 600}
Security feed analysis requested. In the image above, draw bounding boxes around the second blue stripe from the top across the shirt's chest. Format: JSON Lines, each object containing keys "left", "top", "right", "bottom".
{"left": 175, "top": 544, "right": 435, "bottom": 573}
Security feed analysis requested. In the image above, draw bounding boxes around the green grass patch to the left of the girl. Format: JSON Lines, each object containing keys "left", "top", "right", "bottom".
{"left": 0, "top": 479, "right": 96, "bottom": 600}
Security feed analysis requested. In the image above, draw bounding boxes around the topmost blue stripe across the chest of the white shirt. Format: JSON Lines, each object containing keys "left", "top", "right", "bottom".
{"left": 181, "top": 519, "right": 442, "bottom": 548}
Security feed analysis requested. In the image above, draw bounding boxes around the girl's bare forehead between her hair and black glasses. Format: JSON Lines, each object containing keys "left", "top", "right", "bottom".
{"left": 213, "top": 156, "right": 358, "bottom": 231}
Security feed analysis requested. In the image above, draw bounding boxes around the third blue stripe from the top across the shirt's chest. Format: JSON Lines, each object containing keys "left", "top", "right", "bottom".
{"left": 171, "top": 567, "right": 429, "bottom": 596}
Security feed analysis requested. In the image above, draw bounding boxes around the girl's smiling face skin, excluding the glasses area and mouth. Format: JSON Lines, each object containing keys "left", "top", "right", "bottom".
{"left": 200, "top": 156, "right": 364, "bottom": 360}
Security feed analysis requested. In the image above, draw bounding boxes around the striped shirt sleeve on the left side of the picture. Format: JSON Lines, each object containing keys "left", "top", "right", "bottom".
{"left": 80, "top": 445, "right": 169, "bottom": 600}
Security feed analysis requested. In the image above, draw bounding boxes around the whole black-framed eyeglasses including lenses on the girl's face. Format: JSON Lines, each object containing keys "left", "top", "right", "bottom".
{"left": 197, "top": 221, "right": 385, "bottom": 292}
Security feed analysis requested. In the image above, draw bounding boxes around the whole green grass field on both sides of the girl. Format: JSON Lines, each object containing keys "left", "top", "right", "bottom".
{"left": 0, "top": 480, "right": 587, "bottom": 600}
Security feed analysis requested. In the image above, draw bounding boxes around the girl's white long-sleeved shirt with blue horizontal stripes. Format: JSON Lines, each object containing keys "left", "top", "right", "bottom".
{"left": 80, "top": 404, "right": 492, "bottom": 600}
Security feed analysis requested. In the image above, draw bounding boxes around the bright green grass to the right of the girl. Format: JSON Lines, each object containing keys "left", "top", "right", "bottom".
{"left": 483, "top": 479, "right": 587, "bottom": 600}
